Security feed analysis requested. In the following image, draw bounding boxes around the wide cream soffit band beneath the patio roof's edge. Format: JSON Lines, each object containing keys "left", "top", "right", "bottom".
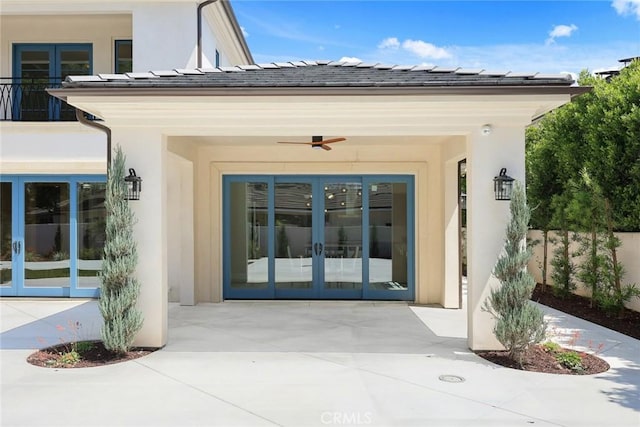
{"left": 68, "top": 94, "right": 569, "bottom": 135}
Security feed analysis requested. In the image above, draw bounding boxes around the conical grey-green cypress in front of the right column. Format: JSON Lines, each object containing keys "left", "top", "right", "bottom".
{"left": 483, "top": 182, "right": 546, "bottom": 365}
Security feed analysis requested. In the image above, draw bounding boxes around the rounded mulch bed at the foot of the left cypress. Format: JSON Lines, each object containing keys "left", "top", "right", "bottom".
{"left": 27, "top": 341, "right": 157, "bottom": 368}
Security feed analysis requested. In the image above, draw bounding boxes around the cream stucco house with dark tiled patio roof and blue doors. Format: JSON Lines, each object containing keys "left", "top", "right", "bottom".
{"left": 0, "top": 0, "right": 585, "bottom": 349}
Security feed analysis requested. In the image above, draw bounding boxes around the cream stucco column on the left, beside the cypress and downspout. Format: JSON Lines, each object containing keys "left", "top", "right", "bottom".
{"left": 112, "top": 128, "right": 168, "bottom": 347}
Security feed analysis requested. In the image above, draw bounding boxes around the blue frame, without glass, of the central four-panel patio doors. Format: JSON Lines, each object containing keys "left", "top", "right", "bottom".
{"left": 222, "top": 175, "right": 416, "bottom": 301}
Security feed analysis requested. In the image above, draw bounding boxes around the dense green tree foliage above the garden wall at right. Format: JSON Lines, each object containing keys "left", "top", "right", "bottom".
{"left": 527, "top": 61, "right": 640, "bottom": 231}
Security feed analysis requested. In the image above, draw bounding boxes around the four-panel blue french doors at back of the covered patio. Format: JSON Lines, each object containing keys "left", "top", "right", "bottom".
{"left": 223, "top": 176, "right": 415, "bottom": 300}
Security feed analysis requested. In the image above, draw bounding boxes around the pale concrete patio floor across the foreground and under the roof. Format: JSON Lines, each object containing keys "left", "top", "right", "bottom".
{"left": 0, "top": 298, "right": 640, "bottom": 426}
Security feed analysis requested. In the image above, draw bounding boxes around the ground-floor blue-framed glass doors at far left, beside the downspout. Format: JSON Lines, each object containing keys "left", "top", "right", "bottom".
{"left": 0, "top": 175, "right": 105, "bottom": 297}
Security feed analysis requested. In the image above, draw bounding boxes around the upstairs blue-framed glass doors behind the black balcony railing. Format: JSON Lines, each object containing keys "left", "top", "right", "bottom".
{"left": 11, "top": 43, "right": 93, "bottom": 121}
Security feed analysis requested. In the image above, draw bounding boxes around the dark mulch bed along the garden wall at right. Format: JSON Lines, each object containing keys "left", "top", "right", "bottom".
{"left": 531, "top": 284, "right": 640, "bottom": 340}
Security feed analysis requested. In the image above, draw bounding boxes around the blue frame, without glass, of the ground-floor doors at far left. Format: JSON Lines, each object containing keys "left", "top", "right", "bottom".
{"left": 0, "top": 175, "right": 107, "bottom": 298}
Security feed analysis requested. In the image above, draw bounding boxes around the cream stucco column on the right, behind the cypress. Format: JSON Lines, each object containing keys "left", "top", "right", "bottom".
{"left": 467, "top": 126, "right": 525, "bottom": 350}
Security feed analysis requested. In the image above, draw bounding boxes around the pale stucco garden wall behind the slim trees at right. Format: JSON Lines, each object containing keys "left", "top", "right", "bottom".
{"left": 529, "top": 230, "right": 640, "bottom": 311}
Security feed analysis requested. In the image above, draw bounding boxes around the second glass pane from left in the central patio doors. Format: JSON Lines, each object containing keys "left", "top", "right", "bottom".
{"left": 275, "top": 183, "right": 313, "bottom": 289}
